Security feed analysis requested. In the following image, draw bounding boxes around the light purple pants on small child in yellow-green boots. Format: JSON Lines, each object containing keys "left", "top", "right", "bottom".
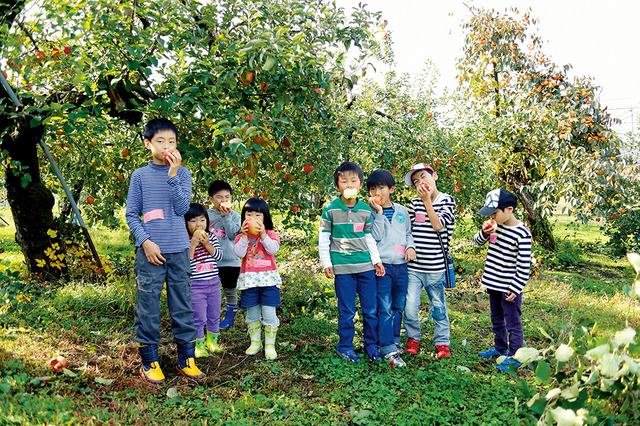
{"left": 191, "top": 277, "right": 221, "bottom": 339}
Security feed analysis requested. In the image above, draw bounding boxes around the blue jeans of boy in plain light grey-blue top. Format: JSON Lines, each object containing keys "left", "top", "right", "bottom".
{"left": 376, "top": 263, "right": 408, "bottom": 355}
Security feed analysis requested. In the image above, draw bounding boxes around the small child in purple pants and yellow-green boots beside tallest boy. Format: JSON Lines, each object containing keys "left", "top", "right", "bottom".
{"left": 184, "top": 203, "right": 222, "bottom": 358}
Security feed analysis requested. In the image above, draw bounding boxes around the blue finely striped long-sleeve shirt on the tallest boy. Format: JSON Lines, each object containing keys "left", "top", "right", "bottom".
{"left": 126, "top": 162, "right": 191, "bottom": 253}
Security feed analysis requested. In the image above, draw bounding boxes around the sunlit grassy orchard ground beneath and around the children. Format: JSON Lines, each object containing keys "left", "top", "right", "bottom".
{"left": 0, "top": 208, "right": 640, "bottom": 425}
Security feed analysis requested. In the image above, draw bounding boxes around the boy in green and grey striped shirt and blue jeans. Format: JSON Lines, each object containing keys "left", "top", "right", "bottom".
{"left": 318, "top": 162, "right": 384, "bottom": 362}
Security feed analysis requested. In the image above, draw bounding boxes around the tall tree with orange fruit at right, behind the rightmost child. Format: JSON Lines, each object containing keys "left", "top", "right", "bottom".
{"left": 459, "top": 7, "right": 627, "bottom": 248}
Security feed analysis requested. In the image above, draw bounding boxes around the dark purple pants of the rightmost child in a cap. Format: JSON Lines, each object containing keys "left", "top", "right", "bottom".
{"left": 487, "top": 289, "right": 524, "bottom": 356}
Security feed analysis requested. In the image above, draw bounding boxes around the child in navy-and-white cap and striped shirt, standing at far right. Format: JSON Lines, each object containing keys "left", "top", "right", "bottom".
{"left": 473, "top": 188, "right": 531, "bottom": 371}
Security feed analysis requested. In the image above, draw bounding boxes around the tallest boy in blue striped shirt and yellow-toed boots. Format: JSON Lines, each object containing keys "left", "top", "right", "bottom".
{"left": 126, "top": 118, "right": 204, "bottom": 384}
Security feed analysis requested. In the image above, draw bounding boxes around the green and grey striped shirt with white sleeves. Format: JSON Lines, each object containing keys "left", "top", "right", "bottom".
{"left": 318, "top": 198, "right": 380, "bottom": 275}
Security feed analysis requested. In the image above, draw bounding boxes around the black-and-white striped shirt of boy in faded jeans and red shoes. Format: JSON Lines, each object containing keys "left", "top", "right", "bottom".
{"left": 407, "top": 192, "right": 456, "bottom": 272}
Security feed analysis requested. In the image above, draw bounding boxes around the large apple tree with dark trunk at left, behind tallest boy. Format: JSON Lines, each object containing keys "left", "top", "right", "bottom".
{"left": 0, "top": 0, "right": 383, "bottom": 277}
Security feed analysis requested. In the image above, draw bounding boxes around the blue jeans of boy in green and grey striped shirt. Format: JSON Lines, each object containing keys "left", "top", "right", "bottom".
{"left": 335, "top": 270, "right": 378, "bottom": 356}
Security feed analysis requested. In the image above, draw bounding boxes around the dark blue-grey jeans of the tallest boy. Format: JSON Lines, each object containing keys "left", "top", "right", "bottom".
{"left": 133, "top": 248, "right": 196, "bottom": 345}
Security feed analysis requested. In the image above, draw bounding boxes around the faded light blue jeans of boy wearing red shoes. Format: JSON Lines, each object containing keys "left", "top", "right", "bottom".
{"left": 404, "top": 270, "right": 451, "bottom": 346}
